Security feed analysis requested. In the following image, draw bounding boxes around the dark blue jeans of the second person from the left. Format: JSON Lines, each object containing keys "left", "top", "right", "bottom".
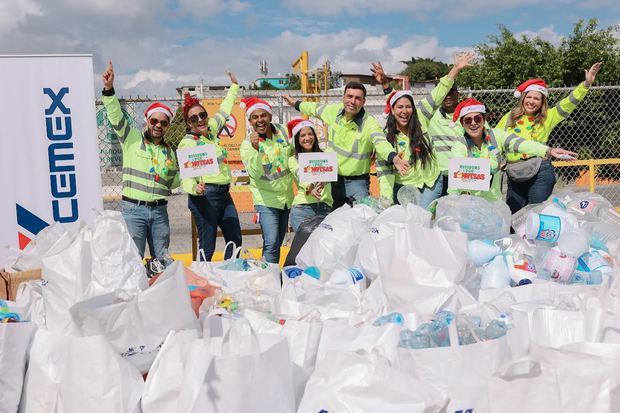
{"left": 187, "top": 184, "right": 241, "bottom": 261}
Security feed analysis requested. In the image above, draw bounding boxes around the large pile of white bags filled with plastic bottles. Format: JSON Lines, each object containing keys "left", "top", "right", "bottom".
{"left": 0, "top": 193, "right": 620, "bottom": 413}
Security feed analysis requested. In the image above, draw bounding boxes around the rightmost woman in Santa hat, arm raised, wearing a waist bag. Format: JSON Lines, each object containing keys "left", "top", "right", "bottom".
{"left": 497, "top": 62, "right": 602, "bottom": 213}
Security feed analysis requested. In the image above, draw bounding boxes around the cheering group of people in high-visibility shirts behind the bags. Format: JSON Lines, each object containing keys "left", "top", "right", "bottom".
{"left": 102, "top": 57, "right": 601, "bottom": 266}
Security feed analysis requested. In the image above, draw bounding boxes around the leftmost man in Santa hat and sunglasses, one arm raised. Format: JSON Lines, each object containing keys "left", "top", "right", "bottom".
{"left": 102, "top": 61, "right": 180, "bottom": 273}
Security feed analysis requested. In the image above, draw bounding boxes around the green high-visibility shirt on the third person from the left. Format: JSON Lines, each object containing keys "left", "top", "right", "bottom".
{"left": 240, "top": 123, "right": 293, "bottom": 209}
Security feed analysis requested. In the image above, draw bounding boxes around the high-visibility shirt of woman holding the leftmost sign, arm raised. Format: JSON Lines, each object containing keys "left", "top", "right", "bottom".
{"left": 179, "top": 83, "right": 239, "bottom": 195}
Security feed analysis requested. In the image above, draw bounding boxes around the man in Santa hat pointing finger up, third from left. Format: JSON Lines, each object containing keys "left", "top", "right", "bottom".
{"left": 240, "top": 97, "right": 293, "bottom": 264}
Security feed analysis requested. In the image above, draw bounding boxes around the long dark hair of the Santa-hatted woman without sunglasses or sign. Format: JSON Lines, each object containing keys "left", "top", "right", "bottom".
{"left": 385, "top": 95, "right": 434, "bottom": 167}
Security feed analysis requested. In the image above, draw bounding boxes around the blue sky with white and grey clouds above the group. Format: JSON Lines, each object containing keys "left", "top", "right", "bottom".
{"left": 0, "top": 0, "right": 620, "bottom": 96}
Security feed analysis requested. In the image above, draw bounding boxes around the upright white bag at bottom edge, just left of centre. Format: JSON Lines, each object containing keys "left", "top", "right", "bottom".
{"left": 176, "top": 320, "right": 295, "bottom": 413}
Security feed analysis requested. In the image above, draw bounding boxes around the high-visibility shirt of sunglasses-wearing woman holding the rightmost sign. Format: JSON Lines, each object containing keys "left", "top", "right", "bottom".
{"left": 448, "top": 128, "right": 549, "bottom": 201}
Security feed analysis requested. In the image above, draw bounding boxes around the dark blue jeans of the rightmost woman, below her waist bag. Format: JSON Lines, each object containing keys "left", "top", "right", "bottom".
{"left": 506, "top": 159, "right": 555, "bottom": 214}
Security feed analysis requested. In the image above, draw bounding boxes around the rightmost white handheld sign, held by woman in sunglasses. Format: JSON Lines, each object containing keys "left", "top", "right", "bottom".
{"left": 448, "top": 158, "right": 491, "bottom": 191}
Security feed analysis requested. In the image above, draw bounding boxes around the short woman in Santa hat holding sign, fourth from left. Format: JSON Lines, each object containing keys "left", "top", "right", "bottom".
{"left": 288, "top": 118, "right": 334, "bottom": 232}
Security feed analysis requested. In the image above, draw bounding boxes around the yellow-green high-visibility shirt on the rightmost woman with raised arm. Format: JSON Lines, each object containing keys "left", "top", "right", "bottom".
{"left": 497, "top": 82, "right": 589, "bottom": 162}
